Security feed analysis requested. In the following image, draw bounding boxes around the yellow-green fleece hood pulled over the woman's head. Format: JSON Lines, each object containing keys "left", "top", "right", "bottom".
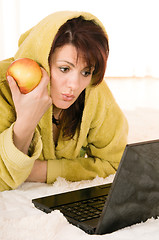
{"left": 14, "top": 11, "right": 106, "bottom": 74}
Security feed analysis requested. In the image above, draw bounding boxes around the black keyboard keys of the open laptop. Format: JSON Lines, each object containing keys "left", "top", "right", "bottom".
{"left": 53, "top": 195, "right": 107, "bottom": 222}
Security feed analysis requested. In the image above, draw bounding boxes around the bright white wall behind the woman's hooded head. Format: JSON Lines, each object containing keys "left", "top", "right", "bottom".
{"left": 0, "top": 0, "right": 159, "bottom": 77}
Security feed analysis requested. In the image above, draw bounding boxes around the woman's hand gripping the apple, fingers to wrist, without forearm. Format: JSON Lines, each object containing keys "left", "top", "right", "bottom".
{"left": 8, "top": 69, "right": 52, "bottom": 127}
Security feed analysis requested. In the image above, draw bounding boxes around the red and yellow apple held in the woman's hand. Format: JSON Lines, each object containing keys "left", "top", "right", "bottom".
{"left": 7, "top": 58, "right": 42, "bottom": 94}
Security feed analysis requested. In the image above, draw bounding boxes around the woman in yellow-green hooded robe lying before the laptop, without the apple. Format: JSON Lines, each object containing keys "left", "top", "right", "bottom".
{"left": 0, "top": 11, "right": 127, "bottom": 191}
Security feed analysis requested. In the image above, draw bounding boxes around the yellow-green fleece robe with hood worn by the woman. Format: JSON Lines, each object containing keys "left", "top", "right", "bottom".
{"left": 0, "top": 11, "right": 128, "bottom": 191}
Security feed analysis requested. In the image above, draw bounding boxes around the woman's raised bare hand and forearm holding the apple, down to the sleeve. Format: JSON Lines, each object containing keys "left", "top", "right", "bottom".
{"left": 7, "top": 69, "right": 52, "bottom": 154}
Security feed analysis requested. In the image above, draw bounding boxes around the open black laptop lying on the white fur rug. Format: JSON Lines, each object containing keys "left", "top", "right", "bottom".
{"left": 32, "top": 140, "right": 159, "bottom": 234}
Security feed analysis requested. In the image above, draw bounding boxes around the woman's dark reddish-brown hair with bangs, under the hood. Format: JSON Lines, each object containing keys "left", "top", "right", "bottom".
{"left": 49, "top": 16, "right": 109, "bottom": 139}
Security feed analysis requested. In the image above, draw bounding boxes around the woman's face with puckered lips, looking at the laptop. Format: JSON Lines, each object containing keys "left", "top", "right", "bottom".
{"left": 50, "top": 44, "right": 94, "bottom": 109}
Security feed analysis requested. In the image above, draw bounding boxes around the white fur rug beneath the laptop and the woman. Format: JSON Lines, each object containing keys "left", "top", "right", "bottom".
{"left": 0, "top": 108, "right": 159, "bottom": 240}
